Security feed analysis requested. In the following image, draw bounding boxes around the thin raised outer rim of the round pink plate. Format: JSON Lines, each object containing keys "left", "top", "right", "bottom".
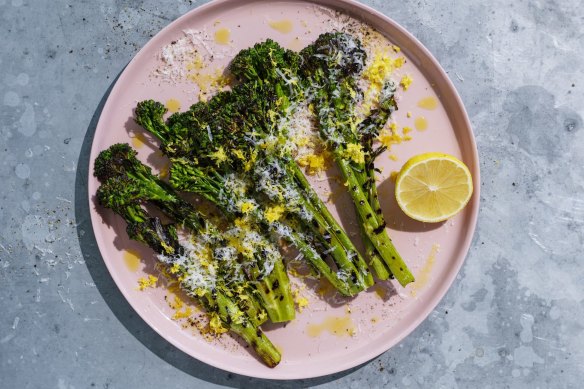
{"left": 88, "top": 0, "right": 480, "bottom": 380}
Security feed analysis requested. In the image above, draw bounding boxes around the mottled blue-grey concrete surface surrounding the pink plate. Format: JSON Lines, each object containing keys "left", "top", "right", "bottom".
{"left": 0, "top": 0, "right": 584, "bottom": 389}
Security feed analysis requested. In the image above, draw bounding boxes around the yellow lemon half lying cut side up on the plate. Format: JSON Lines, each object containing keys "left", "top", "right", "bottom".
{"left": 395, "top": 153, "right": 473, "bottom": 223}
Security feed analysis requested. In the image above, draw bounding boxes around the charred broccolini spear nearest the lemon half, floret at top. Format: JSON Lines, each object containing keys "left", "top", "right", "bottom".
{"left": 301, "top": 33, "right": 414, "bottom": 286}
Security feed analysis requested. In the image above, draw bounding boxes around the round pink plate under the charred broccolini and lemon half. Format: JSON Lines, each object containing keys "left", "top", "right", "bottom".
{"left": 89, "top": 0, "right": 480, "bottom": 379}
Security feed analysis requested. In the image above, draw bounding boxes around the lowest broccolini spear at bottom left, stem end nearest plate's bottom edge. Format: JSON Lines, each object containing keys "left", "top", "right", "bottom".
{"left": 97, "top": 177, "right": 281, "bottom": 367}
